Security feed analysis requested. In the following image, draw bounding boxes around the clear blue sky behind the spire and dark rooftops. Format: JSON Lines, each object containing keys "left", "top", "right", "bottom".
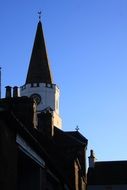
{"left": 0, "top": 0, "right": 127, "bottom": 161}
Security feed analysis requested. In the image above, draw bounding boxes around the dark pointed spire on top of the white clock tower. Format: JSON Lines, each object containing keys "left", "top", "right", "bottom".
{"left": 26, "top": 21, "right": 52, "bottom": 84}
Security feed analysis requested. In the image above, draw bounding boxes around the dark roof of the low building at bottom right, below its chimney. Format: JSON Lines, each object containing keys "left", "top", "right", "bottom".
{"left": 88, "top": 161, "right": 127, "bottom": 185}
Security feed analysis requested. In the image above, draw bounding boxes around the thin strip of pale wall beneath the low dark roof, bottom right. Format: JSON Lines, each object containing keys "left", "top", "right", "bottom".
{"left": 87, "top": 185, "right": 127, "bottom": 190}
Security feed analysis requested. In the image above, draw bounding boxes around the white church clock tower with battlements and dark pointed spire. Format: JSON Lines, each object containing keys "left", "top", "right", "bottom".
{"left": 20, "top": 20, "right": 61, "bottom": 128}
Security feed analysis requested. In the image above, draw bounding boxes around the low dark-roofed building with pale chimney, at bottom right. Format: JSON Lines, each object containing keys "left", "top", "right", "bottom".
{"left": 87, "top": 151, "right": 127, "bottom": 190}
